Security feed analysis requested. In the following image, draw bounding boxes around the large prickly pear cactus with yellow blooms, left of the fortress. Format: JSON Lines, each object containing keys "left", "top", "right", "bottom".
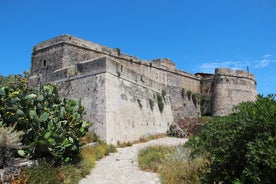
{"left": 0, "top": 79, "right": 89, "bottom": 162}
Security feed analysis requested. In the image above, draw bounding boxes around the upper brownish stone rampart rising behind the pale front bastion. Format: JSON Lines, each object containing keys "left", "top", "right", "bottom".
{"left": 31, "top": 35, "right": 199, "bottom": 90}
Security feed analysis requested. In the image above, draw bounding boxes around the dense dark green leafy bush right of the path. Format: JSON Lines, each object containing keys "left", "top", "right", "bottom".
{"left": 186, "top": 95, "right": 276, "bottom": 183}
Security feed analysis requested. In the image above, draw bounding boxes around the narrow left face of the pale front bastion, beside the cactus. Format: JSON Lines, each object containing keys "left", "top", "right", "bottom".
{"left": 55, "top": 68, "right": 107, "bottom": 140}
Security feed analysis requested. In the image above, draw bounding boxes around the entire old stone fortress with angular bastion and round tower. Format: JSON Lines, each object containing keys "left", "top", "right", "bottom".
{"left": 30, "top": 35, "right": 257, "bottom": 144}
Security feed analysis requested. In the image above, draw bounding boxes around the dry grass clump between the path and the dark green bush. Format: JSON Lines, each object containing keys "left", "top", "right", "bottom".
{"left": 138, "top": 146, "right": 208, "bottom": 184}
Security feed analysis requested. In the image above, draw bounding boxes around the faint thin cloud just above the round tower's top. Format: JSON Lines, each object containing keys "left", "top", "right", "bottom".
{"left": 200, "top": 61, "right": 247, "bottom": 73}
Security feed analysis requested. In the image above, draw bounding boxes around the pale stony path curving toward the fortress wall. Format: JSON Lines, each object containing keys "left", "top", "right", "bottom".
{"left": 79, "top": 137, "right": 187, "bottom": 184}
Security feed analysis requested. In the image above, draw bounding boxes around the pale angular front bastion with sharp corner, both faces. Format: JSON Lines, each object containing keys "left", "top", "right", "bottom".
{"left": 55, "top": 57, "right": 173, "bottom": 144}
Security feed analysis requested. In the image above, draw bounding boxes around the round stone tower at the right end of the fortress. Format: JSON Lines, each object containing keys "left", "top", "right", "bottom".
{"left": 212, "top": 68, "right": 257, "bottom": 116}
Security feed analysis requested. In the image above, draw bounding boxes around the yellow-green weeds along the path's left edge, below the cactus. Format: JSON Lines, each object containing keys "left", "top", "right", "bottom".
{"left": 12, "top": 143, "right": 116, "bottom": 184}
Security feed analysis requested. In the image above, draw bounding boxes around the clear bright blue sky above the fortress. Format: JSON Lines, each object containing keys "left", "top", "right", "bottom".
{"left": 0, "top": 0, "right": 276, "bottom": 95}
